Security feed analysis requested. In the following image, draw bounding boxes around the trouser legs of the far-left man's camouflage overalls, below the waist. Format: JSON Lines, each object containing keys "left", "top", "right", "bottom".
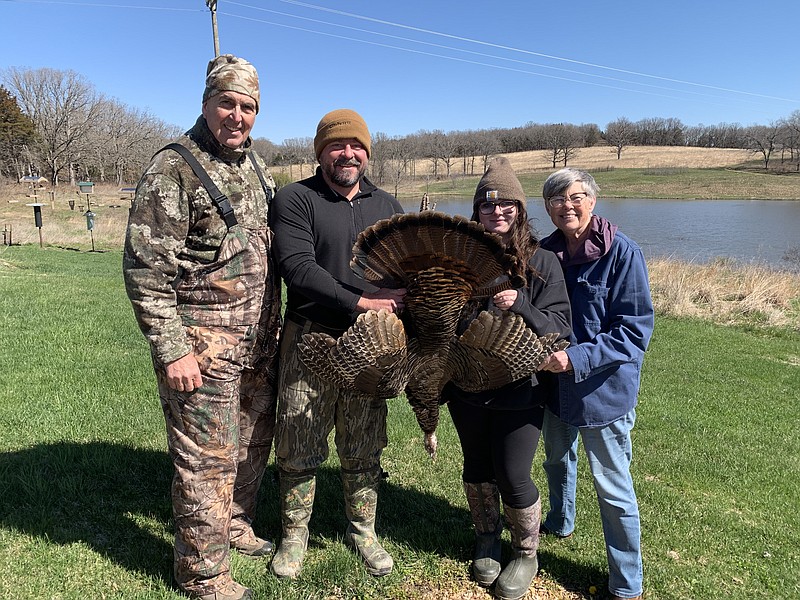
{"left": 154, "top": 326, "right": 275, "bottom": 594}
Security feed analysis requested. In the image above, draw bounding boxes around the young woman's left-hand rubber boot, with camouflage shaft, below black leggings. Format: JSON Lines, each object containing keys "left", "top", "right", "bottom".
{"left": 463, "top": 481, "right": 503, "bottom": 587}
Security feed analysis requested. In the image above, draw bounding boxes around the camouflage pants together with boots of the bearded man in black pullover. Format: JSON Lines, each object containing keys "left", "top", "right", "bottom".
{"left": 273, "top": 317, "right": 392, "bottom": 577}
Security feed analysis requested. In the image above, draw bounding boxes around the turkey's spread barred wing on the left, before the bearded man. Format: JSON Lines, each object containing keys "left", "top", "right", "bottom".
{"left": 299, "top": 310, "right": 408, "bottom": 399}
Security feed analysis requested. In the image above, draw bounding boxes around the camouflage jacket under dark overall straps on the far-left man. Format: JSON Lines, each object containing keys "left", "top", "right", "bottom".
{"left": 123, "top": 117, "right": 275, "bottom": 363}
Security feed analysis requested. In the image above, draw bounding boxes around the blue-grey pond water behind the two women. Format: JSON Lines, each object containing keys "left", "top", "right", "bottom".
{"left": 403, "top": 198, "right": 800, "bottom": 268}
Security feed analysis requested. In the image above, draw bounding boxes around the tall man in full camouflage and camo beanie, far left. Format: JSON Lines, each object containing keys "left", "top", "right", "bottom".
{"left": 123, "top": 54, "right": 280, "bottom": 600}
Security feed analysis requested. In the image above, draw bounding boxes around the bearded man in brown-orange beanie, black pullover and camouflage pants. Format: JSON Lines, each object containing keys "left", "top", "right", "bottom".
{"left": 270, "top": 109, "right": 405, "bottom": 578}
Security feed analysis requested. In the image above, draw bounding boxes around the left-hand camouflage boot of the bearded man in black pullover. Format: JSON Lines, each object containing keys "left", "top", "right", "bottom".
{"left": 270, "top": 471, "right": 317, "bottom": 579}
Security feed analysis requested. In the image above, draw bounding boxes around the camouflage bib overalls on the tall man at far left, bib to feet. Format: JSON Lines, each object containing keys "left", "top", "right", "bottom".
{"left": 154, "top": 225, "right": 280, "bottom": 598}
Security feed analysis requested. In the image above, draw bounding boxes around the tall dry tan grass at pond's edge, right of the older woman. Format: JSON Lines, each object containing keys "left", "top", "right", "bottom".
{"left": 648, "top": 258, "right": 800, "bottom": 331}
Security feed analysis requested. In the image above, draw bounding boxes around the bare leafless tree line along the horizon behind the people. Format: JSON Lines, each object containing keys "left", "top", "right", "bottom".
{"left": 0, "top": 67, "right": 800, "bottom": 193}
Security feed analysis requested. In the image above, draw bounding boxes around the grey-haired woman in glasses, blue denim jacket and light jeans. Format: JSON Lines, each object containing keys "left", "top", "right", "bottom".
{"left": 541, "top": 168, "right": 653, "bottom": 599}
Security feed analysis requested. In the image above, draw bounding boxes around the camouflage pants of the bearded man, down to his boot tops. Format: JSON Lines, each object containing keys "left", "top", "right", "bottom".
{"left": 275, "top": 320, "right": 388, "bottom": 473}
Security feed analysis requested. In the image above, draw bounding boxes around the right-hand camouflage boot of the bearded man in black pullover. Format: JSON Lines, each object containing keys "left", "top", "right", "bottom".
{"left": 342, "top": 467, "right": 394, "bottom": 577}
